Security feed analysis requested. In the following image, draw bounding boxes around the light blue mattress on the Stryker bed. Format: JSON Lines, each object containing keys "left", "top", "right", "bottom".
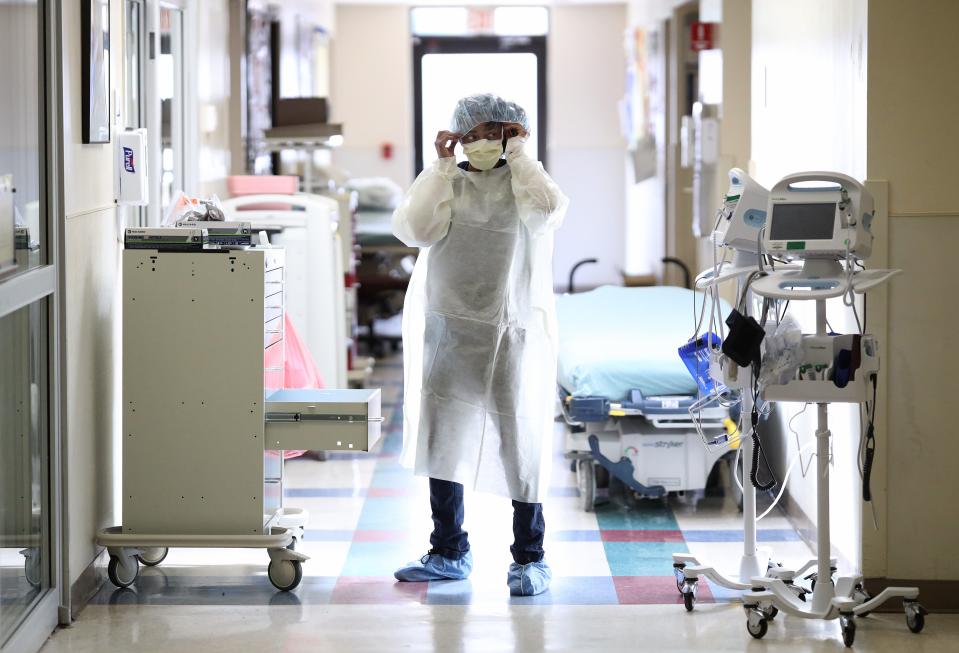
{"left": 556, "top": 286, "right": 730, "bottom": 400}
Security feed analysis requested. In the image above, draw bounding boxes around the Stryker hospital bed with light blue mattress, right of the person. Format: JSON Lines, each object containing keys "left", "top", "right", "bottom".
{"left": 556, "top": 286, "right": 735, "bottom": 511}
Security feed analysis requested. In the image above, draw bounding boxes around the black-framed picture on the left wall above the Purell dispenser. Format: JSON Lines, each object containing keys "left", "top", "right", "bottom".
{"left": 80, "top": 0, "right": 110, "bottom": 143}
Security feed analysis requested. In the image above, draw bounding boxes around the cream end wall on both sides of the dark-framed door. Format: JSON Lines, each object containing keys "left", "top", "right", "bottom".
{"left": 331, "top": 4, "right": 626, "bottom": 286}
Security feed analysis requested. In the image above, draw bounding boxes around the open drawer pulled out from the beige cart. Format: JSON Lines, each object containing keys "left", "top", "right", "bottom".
{"left": 265, "top": 388, "right": 383, "bottom": 451}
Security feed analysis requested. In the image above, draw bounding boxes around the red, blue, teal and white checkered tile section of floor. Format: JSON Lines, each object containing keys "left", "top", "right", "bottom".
{"left": 86, "top": 358, "right": 810, "bottom": 606}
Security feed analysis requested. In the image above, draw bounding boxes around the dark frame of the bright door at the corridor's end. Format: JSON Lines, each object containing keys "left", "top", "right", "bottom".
{"left": 413, "top": 36, "right": 549, "bottom": 175}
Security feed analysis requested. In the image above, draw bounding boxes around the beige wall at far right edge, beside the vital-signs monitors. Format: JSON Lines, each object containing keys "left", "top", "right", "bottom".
{"left": 865, "top": 0, "right": 959, "bottom": 581}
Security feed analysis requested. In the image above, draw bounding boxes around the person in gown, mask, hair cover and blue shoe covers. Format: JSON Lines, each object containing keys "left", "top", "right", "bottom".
{"left": 393, "top": 94, "right": 569, "bottom": 595}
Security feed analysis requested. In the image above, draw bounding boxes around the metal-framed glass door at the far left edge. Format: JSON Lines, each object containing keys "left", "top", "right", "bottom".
{"left": 0, "top": 0, "right": 61, "bottom": 651}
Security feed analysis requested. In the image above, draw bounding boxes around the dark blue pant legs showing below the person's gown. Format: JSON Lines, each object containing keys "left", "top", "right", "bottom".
{"left": 430, "top": 478, "right": 546, "bottom": 565}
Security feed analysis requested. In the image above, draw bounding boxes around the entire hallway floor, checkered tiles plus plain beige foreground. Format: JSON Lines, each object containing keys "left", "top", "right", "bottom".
{"left": 45, "top": 359, "right": 959, "bottom": 652}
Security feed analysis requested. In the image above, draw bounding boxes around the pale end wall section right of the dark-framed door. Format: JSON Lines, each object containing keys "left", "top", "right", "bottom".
{"left": 546, "top": 5, "right": 626, "bottom": 288}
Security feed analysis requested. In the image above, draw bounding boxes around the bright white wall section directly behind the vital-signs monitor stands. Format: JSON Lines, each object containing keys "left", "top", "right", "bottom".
{"left": 751, "top": 0, "right": 867, "bottom": 567}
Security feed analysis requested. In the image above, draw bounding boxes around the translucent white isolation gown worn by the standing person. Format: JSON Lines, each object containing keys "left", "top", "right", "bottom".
{"left": 393, "top": 138, "right": 568, "bottom": 503}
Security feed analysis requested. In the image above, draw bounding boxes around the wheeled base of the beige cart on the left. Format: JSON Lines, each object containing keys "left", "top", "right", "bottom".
{"left": 97, "top": 526, "right": 309, "bottom": 592}
